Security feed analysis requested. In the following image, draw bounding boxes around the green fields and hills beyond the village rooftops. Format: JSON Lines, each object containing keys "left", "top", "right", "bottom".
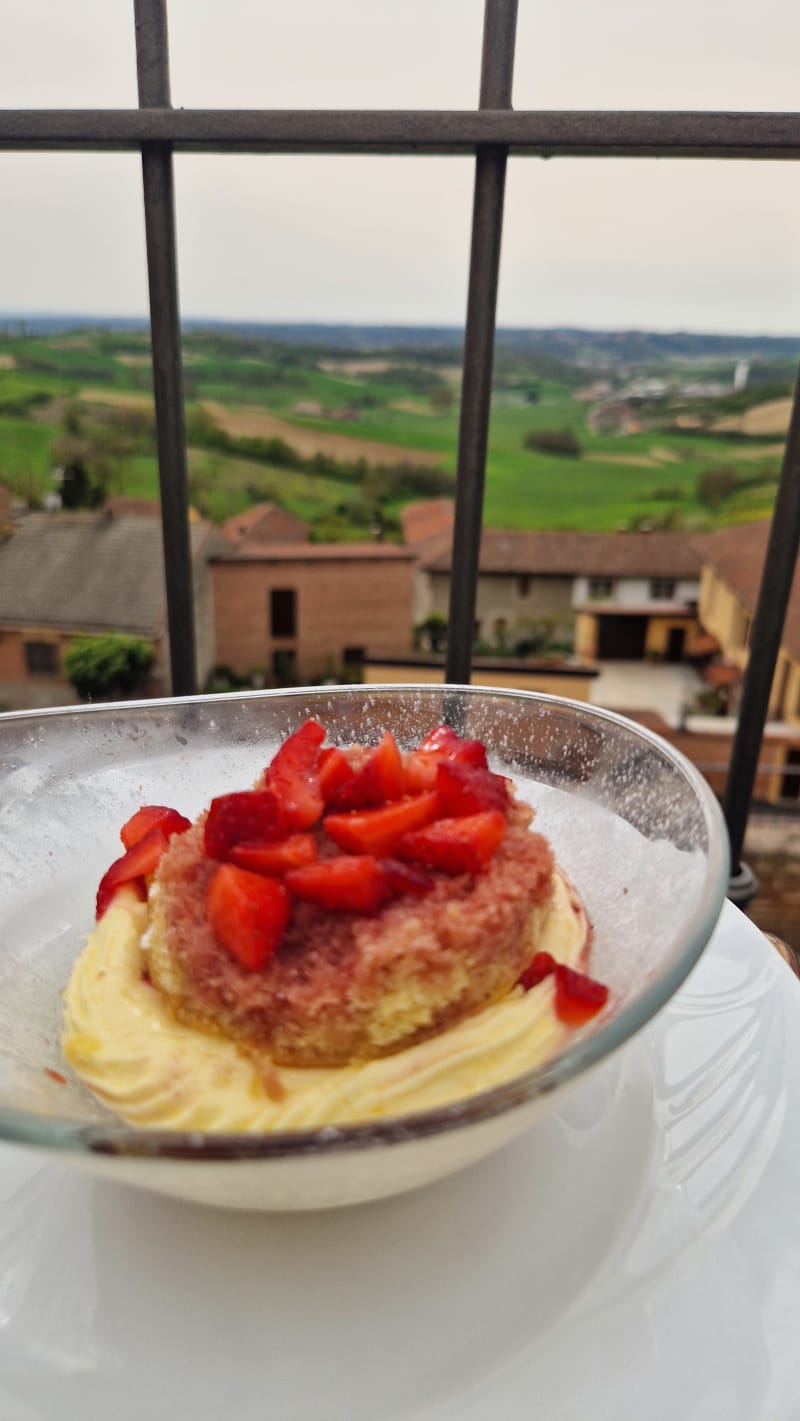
{"left": 0, "top": 331, "right": 783, "bottom": 539}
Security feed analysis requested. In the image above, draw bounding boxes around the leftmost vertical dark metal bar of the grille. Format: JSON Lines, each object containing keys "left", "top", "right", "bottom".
{"left": 134, "top": 0, "right": 198, "bottom": 695}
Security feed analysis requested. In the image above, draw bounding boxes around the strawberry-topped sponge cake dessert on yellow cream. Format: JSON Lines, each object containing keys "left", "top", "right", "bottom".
{"left": 64, "top": 720, "right": 608, "bottom": 1130}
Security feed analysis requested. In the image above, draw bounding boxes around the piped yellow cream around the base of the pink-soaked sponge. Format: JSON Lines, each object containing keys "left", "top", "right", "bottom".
{"left": 63, "top": 875, "right": 587, "bottom": 1133}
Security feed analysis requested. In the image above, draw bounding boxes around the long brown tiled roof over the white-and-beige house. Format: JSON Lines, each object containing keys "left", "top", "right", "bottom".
{"left": 421, "top": 529, "right": 701, "bottom": 577}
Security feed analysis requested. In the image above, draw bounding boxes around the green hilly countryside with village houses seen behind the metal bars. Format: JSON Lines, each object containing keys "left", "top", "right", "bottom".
{"left": 0, "top": 317, "right": 800, "bottom": 824}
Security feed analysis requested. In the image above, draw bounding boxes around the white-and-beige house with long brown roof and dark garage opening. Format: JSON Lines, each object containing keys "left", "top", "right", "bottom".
{"left": 415, "top": 517, "right": 701, "bottom": 662}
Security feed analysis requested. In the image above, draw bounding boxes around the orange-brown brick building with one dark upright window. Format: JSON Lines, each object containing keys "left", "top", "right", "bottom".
{"left": 212, "top": 537, "right": 413, "bottom": 685}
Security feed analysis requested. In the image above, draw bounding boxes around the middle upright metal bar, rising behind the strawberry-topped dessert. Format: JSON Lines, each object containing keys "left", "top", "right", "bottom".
{"left": 445, "top": 0, "right": 517, "bottom": 682}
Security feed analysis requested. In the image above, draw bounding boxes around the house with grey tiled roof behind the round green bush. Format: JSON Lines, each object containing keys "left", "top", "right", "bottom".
{"left": 0, "top": 509, "right": 220, "bottom": 709}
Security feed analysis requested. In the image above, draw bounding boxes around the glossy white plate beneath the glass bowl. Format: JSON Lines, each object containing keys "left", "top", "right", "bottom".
{"left": 0, "top": 904, "right": 800, "bottom": 1421}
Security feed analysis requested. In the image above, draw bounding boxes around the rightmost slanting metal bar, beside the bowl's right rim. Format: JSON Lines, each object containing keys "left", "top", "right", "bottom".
{"left": 722, "top": 375, "right": 800, "bottom": 875}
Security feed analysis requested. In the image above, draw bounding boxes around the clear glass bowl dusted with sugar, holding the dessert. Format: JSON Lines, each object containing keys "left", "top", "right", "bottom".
{"left": 0, "top": 685, "right": 729, "bottom": 1209}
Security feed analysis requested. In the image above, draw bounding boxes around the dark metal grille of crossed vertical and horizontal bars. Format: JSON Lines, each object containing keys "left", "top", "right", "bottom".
{"left": 0, "top": 0, "right": 800, "bottom": 898}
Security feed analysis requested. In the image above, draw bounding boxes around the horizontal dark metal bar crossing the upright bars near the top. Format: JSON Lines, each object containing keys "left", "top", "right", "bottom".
{"left": 0, "top": 108, "right": 800, "bottom": 159}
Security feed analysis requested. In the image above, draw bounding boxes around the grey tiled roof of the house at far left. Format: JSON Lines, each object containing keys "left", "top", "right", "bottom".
{"left": 0, "top": 513, "right": 216, "bottom": 637}
